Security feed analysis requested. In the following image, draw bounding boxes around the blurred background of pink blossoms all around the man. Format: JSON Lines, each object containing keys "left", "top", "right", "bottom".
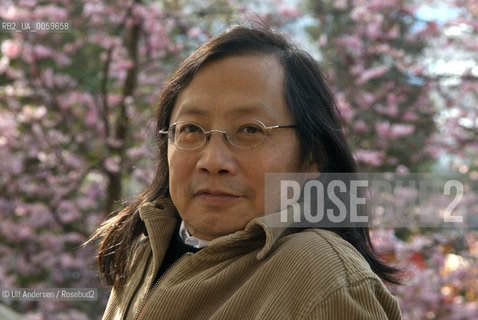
{"left": 0, "top": 0, "right": 478, "bottom": 320}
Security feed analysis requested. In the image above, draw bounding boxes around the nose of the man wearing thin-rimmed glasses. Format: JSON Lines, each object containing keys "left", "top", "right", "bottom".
{"left": 196, "top": 130, "right": 238, "bottom": 175}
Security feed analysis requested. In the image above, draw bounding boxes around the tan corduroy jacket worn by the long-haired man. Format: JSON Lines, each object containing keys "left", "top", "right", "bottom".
{"left": 103, "top": 199, "right": 401, "bottom": 320}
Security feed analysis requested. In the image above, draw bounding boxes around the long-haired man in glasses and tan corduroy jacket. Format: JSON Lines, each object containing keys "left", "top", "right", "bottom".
{"left": 92, "top": 26, "right": 400, "bottom": 320}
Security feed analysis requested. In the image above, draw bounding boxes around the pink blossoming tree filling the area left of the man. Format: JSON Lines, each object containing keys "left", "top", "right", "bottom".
{"left": 0, "top": 1, "right": 245, "bottom": 319}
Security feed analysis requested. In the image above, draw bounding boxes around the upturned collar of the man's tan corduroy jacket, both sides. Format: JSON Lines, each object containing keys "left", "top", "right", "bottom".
{"left": 139, "top": 198, "right": 297, "bottom": 267}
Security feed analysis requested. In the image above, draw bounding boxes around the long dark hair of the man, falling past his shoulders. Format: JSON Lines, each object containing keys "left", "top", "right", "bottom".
{"left": 92, "top": 26, "right": 399, "bottom": 289}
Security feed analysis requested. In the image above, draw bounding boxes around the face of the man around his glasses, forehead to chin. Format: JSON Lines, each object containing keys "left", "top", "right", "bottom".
{"left": 168, "top": 55, "right": 299, "bottom": 240}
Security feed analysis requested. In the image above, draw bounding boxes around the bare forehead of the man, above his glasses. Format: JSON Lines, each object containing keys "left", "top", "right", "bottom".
{"left": 171, "top": 55, "right": 290, "bottom": 122}
